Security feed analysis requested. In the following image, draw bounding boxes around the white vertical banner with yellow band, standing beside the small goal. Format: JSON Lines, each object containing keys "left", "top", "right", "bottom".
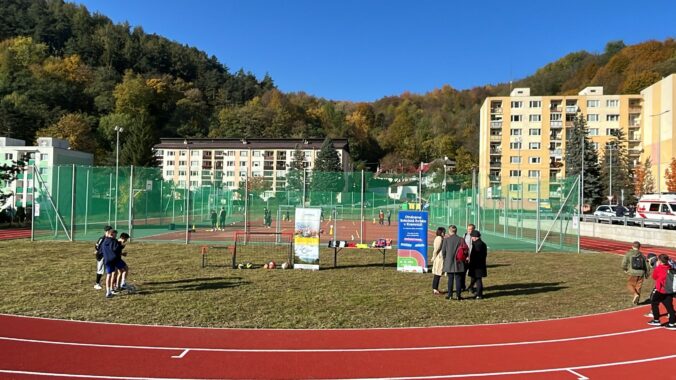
{"left": 293, "top": 208, "right": 322, "bottom": 270}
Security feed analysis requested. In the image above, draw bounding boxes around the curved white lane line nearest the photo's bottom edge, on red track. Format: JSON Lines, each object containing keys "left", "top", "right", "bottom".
{"left": 0, "top": 355, "right": 676, "bottom": 380}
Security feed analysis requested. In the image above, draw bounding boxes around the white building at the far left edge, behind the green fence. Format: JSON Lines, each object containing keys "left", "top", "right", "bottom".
{"left": 0, "top": 137, "right": 94, "bottom": 208}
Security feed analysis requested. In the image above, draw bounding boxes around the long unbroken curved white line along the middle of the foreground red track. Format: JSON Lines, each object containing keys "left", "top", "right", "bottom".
{"left": 0, "top": 327, "right": 661, "bottom": 353}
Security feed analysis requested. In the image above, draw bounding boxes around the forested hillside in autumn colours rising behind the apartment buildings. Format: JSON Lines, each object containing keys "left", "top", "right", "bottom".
{"left": 0, "top": 0, "right": 676, "bottom": 172}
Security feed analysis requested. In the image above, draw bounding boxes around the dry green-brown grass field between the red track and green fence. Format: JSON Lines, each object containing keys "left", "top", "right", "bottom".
{"left": 0, "top": 241, "right": 653, "bottom": 328}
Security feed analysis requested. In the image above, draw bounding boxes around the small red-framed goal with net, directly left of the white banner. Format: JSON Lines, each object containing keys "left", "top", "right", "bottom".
{"left": 232, "top": 232, "right": 293, "bottom": 269}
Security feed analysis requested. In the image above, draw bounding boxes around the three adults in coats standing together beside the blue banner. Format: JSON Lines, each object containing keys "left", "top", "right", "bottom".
{"left": 432, "top": 224, "right": 488, "bottom": 300}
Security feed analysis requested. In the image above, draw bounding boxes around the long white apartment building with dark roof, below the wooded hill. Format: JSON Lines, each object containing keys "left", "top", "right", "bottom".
{"left": 154, "top": 138, "right": 351, "bottom": 191}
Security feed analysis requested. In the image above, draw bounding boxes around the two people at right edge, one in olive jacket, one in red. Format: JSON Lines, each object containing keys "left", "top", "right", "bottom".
{"left": 622, "top": 241, "right": 676, "bottom": 329}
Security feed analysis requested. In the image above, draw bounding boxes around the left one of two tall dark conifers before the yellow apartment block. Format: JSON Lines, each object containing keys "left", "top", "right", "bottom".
{"left": 565, "top": 113, "right": 603, "bottom": 205}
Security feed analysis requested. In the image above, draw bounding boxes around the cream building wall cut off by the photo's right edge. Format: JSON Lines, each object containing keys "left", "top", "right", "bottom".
{"left": 641, "top": 74, "right": 676, "bottom": 191}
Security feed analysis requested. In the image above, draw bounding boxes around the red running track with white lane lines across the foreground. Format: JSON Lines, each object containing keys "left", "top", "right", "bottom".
{"left": 0, "top": 307, "right": 676, "bottom": 379}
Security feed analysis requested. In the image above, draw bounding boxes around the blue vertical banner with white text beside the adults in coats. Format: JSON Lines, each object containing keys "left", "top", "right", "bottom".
{"left": 397, "top": 211, "right": 427, "bottom": 273}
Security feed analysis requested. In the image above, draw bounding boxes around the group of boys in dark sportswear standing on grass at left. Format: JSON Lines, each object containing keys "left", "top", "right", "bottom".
{"left": 94, "top": 226, "right": 129, "bottom": 298}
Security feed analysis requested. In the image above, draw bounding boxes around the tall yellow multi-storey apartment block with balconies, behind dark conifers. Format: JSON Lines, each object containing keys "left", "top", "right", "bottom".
{"left": 479, "top": 87, "right": 644, "bottom": 203}
